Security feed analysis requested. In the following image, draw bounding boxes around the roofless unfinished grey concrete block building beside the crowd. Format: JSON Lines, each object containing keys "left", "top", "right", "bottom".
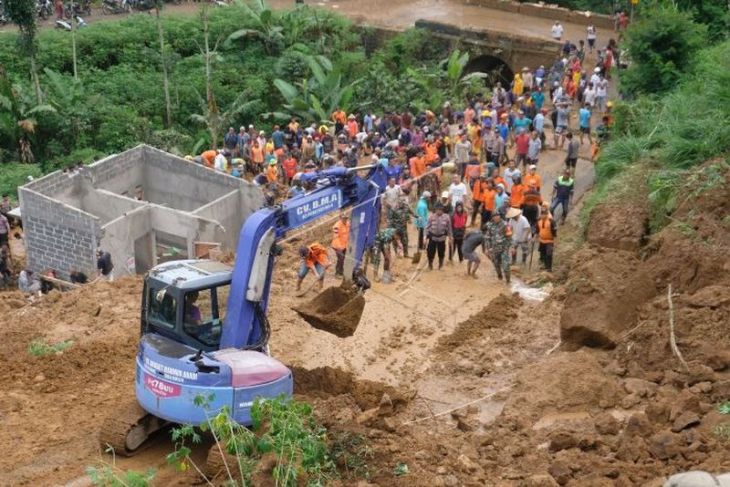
{"left": 19, "top": 145, "right": 263, "bottom": 277}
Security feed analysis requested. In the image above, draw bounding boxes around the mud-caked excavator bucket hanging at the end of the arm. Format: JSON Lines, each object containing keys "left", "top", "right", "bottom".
{"left": 292, "top": 287, "right": 365, "bottom": 338}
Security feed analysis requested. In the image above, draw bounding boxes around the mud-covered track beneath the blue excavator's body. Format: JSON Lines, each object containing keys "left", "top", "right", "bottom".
{"left": 99, "top": 401, "right": 168, "bottom": 457}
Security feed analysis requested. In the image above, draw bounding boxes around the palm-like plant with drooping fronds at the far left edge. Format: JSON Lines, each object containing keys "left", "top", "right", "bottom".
{"left": 0, "top": 71, "right": 56, "bottom": 163}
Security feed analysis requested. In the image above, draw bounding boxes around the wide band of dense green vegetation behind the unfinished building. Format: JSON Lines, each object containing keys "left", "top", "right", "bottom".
{"left": 0, "top": 0, "right": 460, "bottom": 184}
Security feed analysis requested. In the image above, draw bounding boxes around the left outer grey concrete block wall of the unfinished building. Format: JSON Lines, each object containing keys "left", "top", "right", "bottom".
{"left": 19, "top": 187, "right": 101, "bottom": 278}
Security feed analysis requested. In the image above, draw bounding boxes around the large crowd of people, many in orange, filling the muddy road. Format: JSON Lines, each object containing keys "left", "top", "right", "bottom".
{"left": 183, "top": 25, "right": 619, "bottom": 288}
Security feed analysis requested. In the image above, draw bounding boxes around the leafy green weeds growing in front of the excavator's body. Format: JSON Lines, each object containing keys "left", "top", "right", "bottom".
{"left": 168, "top": 396, "right": 337, "bottom": 486}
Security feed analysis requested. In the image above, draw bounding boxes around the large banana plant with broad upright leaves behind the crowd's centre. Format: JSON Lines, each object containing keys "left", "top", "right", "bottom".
{"left": 268, "top": 55, "right": 361, "bottom": 122}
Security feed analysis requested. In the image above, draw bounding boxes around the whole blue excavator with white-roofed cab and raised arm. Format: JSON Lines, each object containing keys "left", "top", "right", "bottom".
{"left": 100, "top": 164, "right": 387, "bottom": 456}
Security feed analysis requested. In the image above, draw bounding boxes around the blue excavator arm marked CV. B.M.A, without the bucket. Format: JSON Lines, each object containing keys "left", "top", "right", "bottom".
{"left": 220, "top": 164, "right": 387, "bottom": 349}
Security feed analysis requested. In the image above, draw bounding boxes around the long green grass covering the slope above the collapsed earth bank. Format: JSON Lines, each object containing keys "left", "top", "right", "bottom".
{"left": 581, "top": 41, "right": 730, "bottom": 232}
